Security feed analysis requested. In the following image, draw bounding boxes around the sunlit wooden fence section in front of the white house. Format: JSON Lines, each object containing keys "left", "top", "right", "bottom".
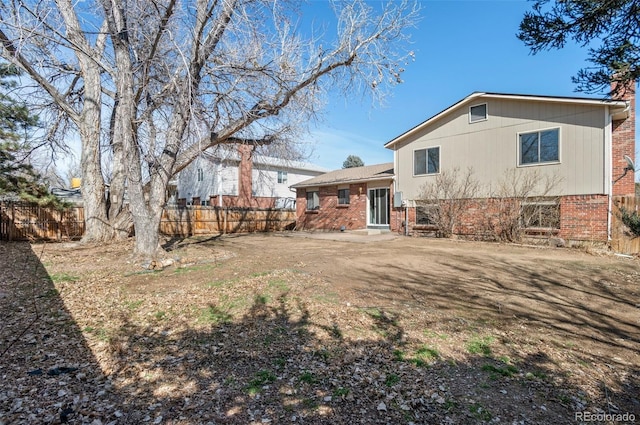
{"left": 160, "top": 206, "right": 296, "bottom": 236}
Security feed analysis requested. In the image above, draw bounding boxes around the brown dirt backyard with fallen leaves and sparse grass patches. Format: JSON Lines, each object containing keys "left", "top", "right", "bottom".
{"left": 0, "top": 233, "right": 640, "bottom": 425}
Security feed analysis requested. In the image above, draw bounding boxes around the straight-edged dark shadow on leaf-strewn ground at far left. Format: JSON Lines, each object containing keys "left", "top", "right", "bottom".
{"left": 0, "top": 242, "right": 122, "bottom": 424}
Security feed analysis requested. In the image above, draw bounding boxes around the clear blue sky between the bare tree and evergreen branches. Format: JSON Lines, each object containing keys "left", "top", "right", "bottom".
{"left": 308, "top": 0, "right": 640, "bottom": 180}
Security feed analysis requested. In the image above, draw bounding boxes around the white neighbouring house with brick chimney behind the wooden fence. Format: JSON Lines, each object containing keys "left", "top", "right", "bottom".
{"left": 169, "top": 145, "right": 328, "bottom": 208}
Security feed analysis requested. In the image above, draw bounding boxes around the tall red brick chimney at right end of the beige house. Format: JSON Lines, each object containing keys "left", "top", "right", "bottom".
{"left": 611, "top": 81, "right": 637, "bottom": 196}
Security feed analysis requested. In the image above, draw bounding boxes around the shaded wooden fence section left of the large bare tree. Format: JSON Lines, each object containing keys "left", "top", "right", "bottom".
{"left": 0, "top": 202, "right": 84, "bottom": 241}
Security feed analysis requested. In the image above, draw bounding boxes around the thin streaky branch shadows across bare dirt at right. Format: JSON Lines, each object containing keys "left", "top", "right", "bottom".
{"left": 352, "top": 254, "right": 640, "bottom": 422}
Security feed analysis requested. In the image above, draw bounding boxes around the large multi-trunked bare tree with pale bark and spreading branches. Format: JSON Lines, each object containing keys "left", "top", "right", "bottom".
{"left": 0, "top": 0, "right": 417, "bottom": 257}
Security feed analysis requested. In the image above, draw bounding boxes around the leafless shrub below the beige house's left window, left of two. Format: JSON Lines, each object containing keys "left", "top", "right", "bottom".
{"left": 420, "top": 167, "right": 480, "bottom": 238}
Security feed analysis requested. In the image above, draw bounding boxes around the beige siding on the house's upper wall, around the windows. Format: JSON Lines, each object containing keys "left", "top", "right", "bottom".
{"left": 396, "top": 99, "right": 605, "bottom": 199}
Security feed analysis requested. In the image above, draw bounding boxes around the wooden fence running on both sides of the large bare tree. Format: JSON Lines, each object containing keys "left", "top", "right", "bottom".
{"left": 0, "top": 202, "right": 296, "bottom": 241}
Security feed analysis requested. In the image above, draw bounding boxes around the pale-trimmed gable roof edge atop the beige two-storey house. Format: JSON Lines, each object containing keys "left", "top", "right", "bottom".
{"left": 384, "top": 92, "right": 630, "bottom": 149}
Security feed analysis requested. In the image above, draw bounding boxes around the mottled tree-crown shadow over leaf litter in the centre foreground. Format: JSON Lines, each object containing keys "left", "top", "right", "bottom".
{"left": 87, "top": 293, "right": 633, "bottom": 424}
